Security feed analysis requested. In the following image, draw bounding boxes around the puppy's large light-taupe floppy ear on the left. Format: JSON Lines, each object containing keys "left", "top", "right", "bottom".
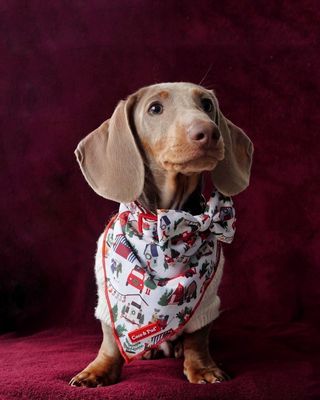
{"left": 75, "top": 96, "right": 144, "bottom": 203}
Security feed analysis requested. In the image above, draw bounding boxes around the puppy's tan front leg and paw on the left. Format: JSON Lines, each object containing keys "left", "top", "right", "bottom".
{"left": 69, "top": 322, "right": 124, "bottom": 387}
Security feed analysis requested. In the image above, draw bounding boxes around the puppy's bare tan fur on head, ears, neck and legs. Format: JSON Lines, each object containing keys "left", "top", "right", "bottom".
{"left": 70, "top": 83, "right": 253, "bottom": 387}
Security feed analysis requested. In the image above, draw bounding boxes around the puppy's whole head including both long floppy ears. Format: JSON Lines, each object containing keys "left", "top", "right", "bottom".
{"left": 75, "top": 83, "right": 253, "bottom": 202}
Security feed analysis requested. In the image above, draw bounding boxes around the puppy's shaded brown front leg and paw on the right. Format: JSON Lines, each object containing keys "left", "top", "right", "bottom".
{"left": 183, "top": 324, "right": 229, "bottom": 383}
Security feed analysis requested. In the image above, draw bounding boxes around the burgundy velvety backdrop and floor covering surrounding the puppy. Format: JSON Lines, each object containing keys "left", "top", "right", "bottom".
{"left": 0, "top": 0, "right": 320, "bottom": 399}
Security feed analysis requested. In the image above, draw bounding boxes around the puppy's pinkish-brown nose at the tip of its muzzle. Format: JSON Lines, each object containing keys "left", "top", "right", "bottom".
{"left": 188, "top": 121, "right": 220, "bottom": 146}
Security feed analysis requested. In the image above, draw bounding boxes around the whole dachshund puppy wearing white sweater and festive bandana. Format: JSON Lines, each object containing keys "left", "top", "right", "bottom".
{"left": 70, "top": 82, "right": 253, "bottom": 387}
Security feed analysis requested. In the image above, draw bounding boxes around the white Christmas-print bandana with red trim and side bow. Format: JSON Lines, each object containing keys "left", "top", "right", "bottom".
{"left": 102, "top": 191, "right": 235, "bottom": 362}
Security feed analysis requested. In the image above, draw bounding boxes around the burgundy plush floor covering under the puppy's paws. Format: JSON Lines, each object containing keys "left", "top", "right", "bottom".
{"left": 0, "top": 325, "right": 320, "bottom": 400}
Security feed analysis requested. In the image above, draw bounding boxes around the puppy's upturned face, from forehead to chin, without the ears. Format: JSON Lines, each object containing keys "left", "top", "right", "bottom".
{"left": 134, "top": 83, "right": 224, "bottom": 175}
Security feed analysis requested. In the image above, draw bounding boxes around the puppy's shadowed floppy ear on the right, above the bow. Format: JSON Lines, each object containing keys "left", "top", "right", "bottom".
{"left": 211, "top": 111, "right": 253, "bottom": 196}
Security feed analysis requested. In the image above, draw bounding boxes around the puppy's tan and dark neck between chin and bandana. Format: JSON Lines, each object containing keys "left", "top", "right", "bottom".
{"left": 139, "top": 164, "right": 203, "bottom": 215}
